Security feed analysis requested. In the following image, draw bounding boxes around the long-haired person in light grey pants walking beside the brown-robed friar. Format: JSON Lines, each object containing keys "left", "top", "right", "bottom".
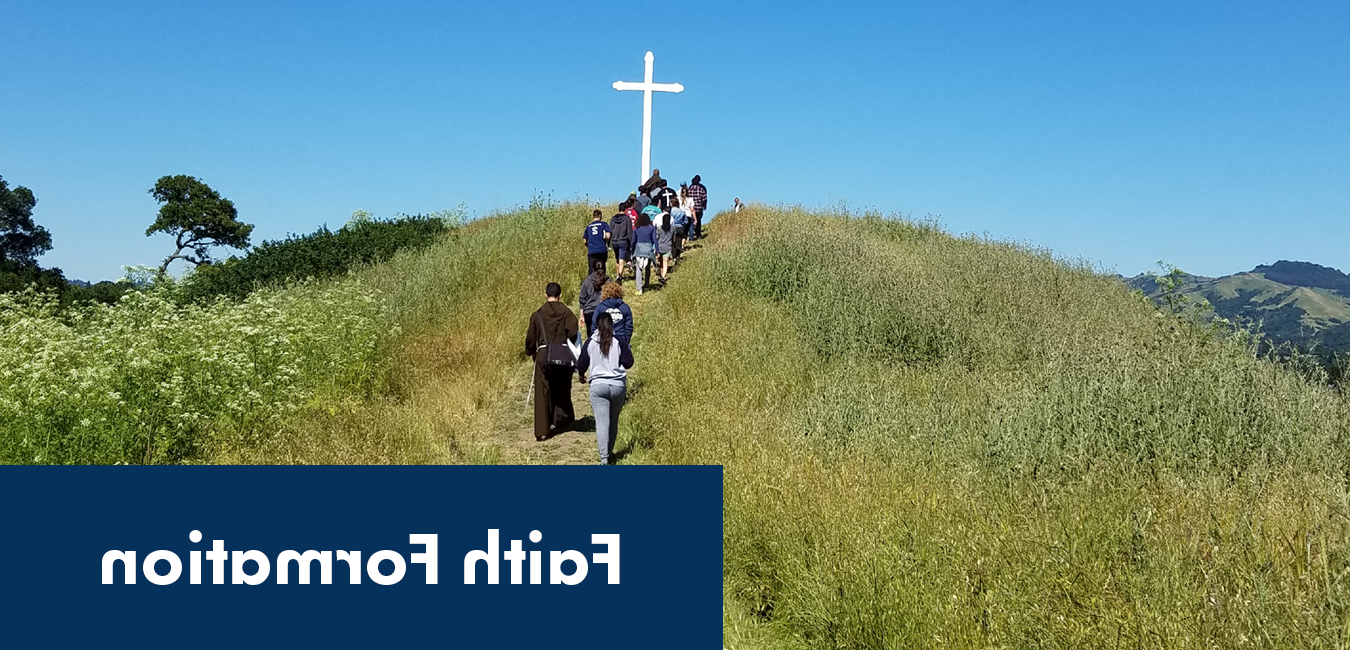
{"left": 576, "top": 312, "right": 633, "bottom": 465}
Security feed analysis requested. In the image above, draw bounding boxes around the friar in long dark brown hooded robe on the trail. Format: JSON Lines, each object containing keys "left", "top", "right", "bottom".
{"left": 525, "top": 282, "right": 576, "bottom": 441}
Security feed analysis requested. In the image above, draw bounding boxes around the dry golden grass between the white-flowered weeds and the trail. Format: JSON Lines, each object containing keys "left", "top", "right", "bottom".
{"left": 227, "top": 200, "right": 590, "bottom": 464}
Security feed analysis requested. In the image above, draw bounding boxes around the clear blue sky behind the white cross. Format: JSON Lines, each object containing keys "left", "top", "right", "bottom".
{"left": 0, "top": 0, "right": 1350, "bottom": 280}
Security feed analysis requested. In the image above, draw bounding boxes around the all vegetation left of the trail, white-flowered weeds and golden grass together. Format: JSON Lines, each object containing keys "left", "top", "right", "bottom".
{"left": 0, "top": 199, "right": 602, "bottom": 464}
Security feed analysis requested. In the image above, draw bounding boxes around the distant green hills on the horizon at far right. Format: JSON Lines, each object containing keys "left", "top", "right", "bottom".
{"left": 1126, "top": 259, "right": 1350, "bottom": 351}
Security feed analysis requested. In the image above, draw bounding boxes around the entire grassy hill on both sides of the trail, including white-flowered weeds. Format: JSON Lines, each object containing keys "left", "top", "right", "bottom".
{"left": 0, "top": 200, "right": 1350, "bottom": 650}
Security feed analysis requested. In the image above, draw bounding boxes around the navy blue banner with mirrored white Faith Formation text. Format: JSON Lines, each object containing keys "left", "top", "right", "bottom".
{"left": 0, "top": 466, "right": 722, "bottom": 649}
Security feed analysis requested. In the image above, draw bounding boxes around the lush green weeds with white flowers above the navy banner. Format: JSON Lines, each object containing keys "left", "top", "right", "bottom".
{"left": 0, "top": 281, "right": 390, "bottom": 464}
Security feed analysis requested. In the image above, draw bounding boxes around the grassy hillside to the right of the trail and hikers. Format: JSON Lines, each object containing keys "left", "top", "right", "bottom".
{"left": 625, "top": 208, "right": 1350, "bottom": 647}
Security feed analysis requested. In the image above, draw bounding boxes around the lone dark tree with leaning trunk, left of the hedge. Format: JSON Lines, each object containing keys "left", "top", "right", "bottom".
{"left": 146, "top": 174, "right": 252, "bottom": 273}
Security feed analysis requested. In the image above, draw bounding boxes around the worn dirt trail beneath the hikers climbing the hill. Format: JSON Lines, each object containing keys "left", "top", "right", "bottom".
{"left": 494, "top": 242, "right": 702, "bottom": 465}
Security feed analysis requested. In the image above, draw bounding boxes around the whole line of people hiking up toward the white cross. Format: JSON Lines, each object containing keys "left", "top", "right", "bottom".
{"left": 525, "top": 169, "right": 712, "bottom": 465}
